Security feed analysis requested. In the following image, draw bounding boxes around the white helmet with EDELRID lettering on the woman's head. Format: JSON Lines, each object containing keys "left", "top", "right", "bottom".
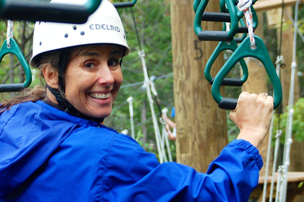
{"left": 30, "top": 0, "right": 130, "bottom": 66}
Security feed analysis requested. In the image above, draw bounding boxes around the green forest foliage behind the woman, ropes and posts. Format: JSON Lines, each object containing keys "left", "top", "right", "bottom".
{"left": 0, "top": 0, "right": 304, "bottom": 159}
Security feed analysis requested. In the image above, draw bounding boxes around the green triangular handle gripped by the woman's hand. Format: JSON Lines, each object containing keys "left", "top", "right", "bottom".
{"left": 211, "top": 36, "right": 282, "bottom": 110}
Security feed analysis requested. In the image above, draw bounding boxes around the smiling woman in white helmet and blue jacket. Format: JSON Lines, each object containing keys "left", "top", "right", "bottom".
{"left": 0, "top": 0, "right": 273, "bottom": 202}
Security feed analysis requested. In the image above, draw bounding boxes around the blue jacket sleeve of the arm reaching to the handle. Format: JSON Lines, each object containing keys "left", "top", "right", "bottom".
{"left": 101, "top": 138, "right": 263, "bottom": 202}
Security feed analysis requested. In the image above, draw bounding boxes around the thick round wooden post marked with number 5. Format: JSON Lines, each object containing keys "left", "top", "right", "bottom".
{"left": 171, "top": 0, "right": 227, "bottom": 172}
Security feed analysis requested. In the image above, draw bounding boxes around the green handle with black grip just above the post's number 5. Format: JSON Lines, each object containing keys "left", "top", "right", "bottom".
{"left": 194, "top": 0, "right": 238, "bottom": 41}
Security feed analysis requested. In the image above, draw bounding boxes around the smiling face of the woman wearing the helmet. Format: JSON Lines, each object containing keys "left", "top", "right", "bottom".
{"left": 65, "top": 45, "right": 123, "bottom": 118}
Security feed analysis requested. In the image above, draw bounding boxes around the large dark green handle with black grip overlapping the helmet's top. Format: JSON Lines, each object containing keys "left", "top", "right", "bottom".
{"left": 0, "top": 0, "right": 102, "bottom": 24}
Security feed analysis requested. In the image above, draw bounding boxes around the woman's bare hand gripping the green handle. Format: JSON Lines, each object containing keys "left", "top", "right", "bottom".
{"left": 229, "top": 92, "right": 273, "bottom": 148}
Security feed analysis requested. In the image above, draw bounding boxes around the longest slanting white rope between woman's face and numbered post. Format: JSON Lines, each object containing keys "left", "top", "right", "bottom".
{"left": 138, "top": 50, "right": 164, "bottom": 163}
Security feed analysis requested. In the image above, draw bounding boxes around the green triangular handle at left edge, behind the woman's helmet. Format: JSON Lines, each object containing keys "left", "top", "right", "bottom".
{"left": 0, "top": 39, "right": 32, "bottom": 92}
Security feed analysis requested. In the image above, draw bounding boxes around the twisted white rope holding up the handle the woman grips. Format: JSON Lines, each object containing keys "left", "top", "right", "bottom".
{"left": 237, "top": 0, "right": 256, "bottom": 48}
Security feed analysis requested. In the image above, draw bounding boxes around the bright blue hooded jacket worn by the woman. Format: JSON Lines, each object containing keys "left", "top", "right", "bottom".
{"left": 0, "top": 101, "right": 263, "bottom": 202}
